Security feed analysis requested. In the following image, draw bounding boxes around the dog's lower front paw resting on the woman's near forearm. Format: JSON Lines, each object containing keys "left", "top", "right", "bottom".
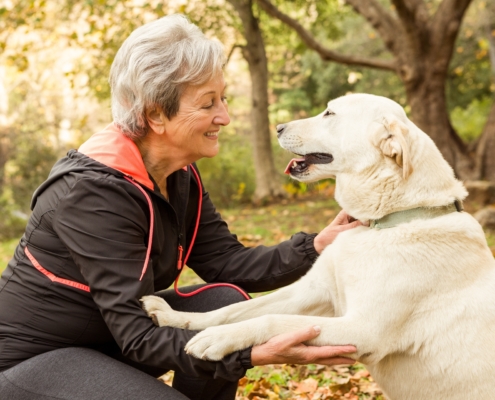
{"left": 185, "top": 325, "right": 252, "bottom": 361}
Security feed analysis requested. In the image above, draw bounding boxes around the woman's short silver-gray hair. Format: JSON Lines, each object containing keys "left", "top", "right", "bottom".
{"left": 109, "top": 14, "right": 225, "bottom": 140}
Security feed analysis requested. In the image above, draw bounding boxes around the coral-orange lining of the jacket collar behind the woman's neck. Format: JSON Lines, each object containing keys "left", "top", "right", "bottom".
{"left": 78, "top": 123, "right": 155, "bottom": 190}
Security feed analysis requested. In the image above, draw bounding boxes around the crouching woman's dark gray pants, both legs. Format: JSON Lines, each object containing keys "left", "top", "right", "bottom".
{"left": 0, "top": 285, "right": 248, "bottom": 400}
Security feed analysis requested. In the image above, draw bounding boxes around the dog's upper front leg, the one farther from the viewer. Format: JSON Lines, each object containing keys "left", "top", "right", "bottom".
{"left": 141, "top": 275, "right": 333, "bottom": 330}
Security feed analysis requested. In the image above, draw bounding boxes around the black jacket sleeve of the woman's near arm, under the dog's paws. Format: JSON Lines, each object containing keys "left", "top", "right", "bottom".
{"left": 54, "top": 179, "right": 250, "bottom": 381}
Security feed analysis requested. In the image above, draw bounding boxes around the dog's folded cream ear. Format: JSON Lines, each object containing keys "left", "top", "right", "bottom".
{"left": 373, "top": 115, "right": 413, "bottom": 179}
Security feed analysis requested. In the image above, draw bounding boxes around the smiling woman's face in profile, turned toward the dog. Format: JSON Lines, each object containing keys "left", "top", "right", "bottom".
{"left": 165, "top": 73, "right": 230, "bottom": 162}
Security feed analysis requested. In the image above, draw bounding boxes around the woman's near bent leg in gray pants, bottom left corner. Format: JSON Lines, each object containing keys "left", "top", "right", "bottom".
{"left": 0, "top": 347, "right": 187, "bottom": 400}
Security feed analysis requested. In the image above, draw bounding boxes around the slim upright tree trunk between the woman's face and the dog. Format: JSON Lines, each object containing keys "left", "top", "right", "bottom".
{"left": 228, "top": 0, "right": 284, "bottom": 203}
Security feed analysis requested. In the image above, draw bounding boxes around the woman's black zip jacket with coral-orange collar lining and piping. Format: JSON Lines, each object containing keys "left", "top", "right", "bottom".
{"left": 0, "top": 125, "right": 317, "bottom": 380}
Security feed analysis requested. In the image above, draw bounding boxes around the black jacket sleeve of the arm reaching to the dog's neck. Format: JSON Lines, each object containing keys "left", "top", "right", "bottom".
{"left": 187, "top": 183, "right": 318, "bottom": 292}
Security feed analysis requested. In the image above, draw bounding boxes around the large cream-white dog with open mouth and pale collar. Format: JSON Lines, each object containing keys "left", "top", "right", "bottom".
{"left": 143, "top": 94, "right": 495, "bottom": 400}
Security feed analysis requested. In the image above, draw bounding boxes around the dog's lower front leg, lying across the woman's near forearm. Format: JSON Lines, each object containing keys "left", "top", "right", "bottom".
{"left": 186, "top": 315, "right": 374, "bottom": 361}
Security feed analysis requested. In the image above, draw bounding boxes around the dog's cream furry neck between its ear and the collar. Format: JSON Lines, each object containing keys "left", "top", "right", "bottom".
{"left": 335, "top": 132, "right": 467, "bottom": 221}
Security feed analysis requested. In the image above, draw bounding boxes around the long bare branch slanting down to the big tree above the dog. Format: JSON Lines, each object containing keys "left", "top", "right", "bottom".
{"left": 256, "top": 0, "right": 396, "bottom": 71}
